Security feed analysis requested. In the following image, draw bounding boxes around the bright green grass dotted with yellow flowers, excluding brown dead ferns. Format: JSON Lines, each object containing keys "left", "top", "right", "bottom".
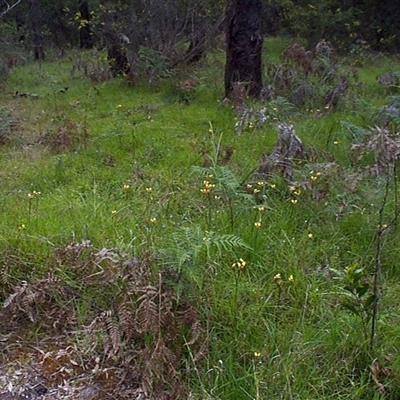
{"left": 0, "top": 40, "right": 400, "bottom": 400}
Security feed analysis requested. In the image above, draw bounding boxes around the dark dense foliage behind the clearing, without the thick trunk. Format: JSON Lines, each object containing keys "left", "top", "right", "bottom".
{"left": 0, "top": 0, "right": 400, "bottom": 69}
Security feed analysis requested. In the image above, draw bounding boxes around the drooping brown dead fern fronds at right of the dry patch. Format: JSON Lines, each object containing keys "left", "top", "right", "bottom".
{"left": 86, "top": 263, "right": 207, "bottom": 399}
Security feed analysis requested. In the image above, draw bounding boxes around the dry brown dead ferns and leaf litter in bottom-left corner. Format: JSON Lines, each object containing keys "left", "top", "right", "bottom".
{"left": 0, "top": 242, "right": 206, "bottom": 399}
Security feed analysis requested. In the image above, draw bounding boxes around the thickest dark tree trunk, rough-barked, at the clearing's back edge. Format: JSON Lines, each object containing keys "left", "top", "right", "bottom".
{"left": 225, "top": 0, "right": 263, "bottom": 98}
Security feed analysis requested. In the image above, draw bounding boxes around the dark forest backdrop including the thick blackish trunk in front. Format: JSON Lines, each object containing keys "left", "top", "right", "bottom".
{"left": 0, "top": 0, "right": 400, "bottom": 78}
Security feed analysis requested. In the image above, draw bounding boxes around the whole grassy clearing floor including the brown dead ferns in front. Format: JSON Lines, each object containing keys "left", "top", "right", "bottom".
{"left": 0, "top": 36, "right": 400, "bottom": 400}
